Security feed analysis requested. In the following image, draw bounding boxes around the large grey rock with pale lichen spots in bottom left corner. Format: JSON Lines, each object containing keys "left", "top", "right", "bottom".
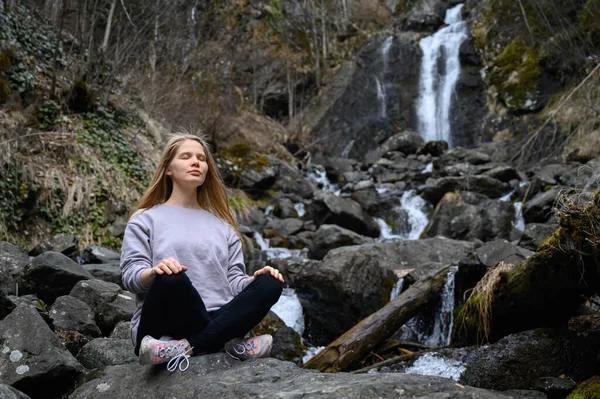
{"left": 0, "top": 306, "right": 83, "bottom": 398}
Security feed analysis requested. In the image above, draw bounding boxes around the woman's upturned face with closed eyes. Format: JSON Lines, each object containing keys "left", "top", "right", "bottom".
{"left": 166, "top": 139, "right": 208, "bottom": 187}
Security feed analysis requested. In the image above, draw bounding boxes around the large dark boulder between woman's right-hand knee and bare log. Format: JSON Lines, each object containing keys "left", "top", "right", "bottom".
{"left": 268, "top": 253, "right": 395, "bottom": 345}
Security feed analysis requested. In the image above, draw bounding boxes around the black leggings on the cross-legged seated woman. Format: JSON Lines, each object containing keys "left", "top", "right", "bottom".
{"left": 135, "top": 272, "right": 283, "bottom": 355}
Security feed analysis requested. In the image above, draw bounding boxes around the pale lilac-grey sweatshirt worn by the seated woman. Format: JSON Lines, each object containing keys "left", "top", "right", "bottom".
{"left": 121, "top": 204, "right": 249, "bottom": 345}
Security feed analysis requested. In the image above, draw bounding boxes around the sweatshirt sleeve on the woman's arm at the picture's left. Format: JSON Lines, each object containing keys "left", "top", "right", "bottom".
{"left": 121, "top": 216, "right": 152, "bottom": 294}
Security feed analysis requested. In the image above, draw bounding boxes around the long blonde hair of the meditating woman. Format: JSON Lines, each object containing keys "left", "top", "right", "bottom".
{"left": 132, "top": 130, "right": 243, "bottom": 239}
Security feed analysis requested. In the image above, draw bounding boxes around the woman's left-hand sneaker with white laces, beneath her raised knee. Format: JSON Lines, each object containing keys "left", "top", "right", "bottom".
{"left": 140, "top": 335, "right": 192, "bottom": 371}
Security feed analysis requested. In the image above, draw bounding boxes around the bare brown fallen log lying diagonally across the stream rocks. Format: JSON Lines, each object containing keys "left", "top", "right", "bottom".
{"left": 302, "top": 267, "right": 449, "bottom": 373}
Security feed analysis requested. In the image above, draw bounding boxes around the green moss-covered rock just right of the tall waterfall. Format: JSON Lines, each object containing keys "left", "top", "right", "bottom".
{"left": 490, "top": 40, "right": 540, "bottom": 111}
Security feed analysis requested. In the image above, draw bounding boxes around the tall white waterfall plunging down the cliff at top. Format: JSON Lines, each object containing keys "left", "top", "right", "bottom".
{"left": 417, "top": 4, "right": 468, "bottom": 146}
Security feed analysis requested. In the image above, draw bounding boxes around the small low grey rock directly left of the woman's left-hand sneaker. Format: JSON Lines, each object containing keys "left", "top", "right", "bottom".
{"left": 77, "top": 338, "right": 138, "bottom": 369}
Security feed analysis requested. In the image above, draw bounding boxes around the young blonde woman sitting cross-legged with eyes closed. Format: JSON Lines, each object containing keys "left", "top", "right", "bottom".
{"left": 121, "top": 133, "right": 284, "bottom": 371}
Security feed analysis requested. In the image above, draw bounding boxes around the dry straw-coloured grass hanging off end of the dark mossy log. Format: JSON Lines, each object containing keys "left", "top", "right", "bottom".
{"left": 456, "top": 262, "right": 514, "bottom": 343}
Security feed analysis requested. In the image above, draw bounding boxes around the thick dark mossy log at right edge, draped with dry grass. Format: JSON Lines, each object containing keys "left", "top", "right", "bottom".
{"left": 453, "top": 191, "right": 600, "bottom": 345}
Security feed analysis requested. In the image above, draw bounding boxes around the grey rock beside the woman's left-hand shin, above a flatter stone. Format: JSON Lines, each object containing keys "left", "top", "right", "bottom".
{"left": 70, "top": 280, "right": 135, "bottom": 336}
